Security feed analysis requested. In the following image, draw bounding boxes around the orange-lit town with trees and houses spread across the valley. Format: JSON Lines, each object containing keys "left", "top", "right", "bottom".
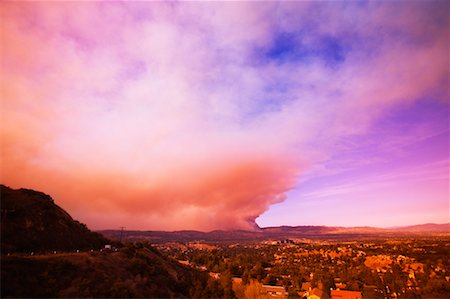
{"left": 153, "top": 237, "right": 450, "bottom": 299}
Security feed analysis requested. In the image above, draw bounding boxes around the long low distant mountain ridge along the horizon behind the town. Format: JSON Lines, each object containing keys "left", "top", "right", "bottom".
{"left": 100, "top": 223, "right": 450, "bottom": 242}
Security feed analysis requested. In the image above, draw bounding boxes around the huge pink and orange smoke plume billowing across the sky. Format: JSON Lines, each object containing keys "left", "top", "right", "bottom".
{"left": 0, "top": 3, "right": 448, "bottom": 230}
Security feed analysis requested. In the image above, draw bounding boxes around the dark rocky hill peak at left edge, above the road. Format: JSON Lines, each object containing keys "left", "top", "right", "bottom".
{"left": 0, "top": 185, "right": 111, "bottom": 253}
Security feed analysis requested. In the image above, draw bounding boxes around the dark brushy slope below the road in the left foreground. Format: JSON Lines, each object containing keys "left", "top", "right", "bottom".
{"left": 1, "top": 246, "right": 208, "bottom": 298}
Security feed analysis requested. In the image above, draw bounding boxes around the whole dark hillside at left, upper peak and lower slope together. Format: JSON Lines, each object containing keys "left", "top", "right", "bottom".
{"left": 0, "top": 185, "right": 224, "bottom": 298}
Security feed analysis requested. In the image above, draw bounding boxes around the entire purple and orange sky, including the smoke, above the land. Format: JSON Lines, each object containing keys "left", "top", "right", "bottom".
{"left": 0, "top": 1, "right": 450, "bottom": 231}
